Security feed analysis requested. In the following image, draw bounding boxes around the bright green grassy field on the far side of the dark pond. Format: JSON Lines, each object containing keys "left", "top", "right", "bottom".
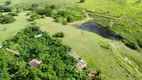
{"left": 79, "top": 0, "right": 142, "bottom": 51}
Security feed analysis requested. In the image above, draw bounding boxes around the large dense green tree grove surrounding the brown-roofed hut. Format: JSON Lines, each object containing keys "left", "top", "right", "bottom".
{"left": 0, "top": 27, "right": 88, "bottom": 80}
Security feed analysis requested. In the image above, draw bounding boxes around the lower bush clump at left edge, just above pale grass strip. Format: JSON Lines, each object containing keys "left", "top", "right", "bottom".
{"left": 0, "top": 13, "right": 16, "bottom": 24}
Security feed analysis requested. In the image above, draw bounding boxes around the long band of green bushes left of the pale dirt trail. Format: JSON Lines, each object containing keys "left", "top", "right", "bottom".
{"left": 36, "top": 5, "right": 85, "bottom": 24}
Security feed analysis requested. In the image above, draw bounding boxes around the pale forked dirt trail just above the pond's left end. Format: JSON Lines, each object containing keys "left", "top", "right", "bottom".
{"left": 69, "top": 10, "right": 94, "bottom": 25}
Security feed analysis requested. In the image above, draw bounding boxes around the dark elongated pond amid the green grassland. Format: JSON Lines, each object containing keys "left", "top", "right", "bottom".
{"left": 77, "top": 22, "right": 121, "bottom": 40}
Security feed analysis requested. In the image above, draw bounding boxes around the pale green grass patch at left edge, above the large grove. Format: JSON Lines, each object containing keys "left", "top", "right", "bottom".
{"left": 0, "top": 12, "right": 28, "bottom": 43}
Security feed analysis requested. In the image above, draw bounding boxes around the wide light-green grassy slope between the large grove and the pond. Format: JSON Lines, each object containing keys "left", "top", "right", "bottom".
{"left": 37, "top": 17, "right": 142, "bottom": 80}
